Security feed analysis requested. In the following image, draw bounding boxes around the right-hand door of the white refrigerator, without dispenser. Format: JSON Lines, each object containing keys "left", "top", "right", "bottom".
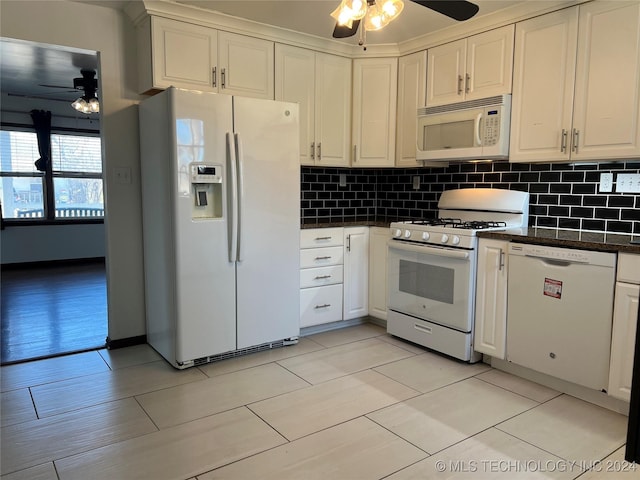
{"left": 233, "top": 97, "right": 300, "bottom": 348}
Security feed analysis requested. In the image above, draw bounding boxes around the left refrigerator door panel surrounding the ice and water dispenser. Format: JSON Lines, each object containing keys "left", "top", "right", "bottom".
{"left": 170, "top": 89, "right": 236, "bottom": 362}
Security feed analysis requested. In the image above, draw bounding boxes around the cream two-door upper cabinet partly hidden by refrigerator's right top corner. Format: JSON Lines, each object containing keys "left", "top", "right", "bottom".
{"left": 275, "top": 44, "right": 351, "bottom": 166}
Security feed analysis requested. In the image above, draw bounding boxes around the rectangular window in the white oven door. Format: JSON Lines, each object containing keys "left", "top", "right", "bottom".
{"left": 398, "top": 260, "right": 455, "bottom": 305}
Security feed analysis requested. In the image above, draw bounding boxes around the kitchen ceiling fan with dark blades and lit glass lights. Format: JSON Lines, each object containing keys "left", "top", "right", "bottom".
{"left": 331, "top": 0, "right": 479, "bottom": 38}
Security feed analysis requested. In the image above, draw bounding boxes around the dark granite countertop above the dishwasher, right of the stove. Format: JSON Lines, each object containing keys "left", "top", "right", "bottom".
{"left": 478, "top": 227, "right": 640, "bottom": 254}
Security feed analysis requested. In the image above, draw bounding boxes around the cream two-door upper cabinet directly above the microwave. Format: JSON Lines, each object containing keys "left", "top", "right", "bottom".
{"left": 427, "top": 25, "right": 514, "bottom": 107}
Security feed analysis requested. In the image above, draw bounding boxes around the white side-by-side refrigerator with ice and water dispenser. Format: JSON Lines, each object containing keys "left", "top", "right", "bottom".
{"left": 139, "top": 88, "right": 300, "bottom": 368}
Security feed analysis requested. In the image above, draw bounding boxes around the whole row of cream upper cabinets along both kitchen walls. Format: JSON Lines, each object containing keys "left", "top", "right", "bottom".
{"left": 138, "top": 0, "right": 640, "bottom": 167}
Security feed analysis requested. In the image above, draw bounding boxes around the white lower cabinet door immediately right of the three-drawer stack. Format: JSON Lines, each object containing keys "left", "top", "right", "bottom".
{"left": 343, "top": 227, "right": 369, "bottom": 320}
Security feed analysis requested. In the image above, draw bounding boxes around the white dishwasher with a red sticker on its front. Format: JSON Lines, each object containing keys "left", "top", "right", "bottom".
{"left": 507, "top": 243, "right": 616, "bottom": 391}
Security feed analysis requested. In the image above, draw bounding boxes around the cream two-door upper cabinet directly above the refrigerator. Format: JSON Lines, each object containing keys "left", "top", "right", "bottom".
{"left": 138, "top": 16, "right": 273, "bottom": 99}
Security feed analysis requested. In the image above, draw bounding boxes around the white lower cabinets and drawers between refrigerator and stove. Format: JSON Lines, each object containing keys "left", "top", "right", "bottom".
{"left": 300, "top": 226, "right": 390, "bottom": 328}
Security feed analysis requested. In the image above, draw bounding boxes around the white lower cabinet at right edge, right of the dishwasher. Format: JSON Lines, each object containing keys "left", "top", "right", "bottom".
{"left": 607, "top": 253, "right": 640, "bottom": 402}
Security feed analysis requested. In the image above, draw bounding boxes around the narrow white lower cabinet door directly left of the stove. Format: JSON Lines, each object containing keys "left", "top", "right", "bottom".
{"left": 369, "top": 227, "right": 391, "bottom": 320}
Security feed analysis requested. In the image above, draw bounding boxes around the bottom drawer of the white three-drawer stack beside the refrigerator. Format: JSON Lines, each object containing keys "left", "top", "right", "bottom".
{"left": 300, "top": 284, "right": 342, "bottom": 327}
